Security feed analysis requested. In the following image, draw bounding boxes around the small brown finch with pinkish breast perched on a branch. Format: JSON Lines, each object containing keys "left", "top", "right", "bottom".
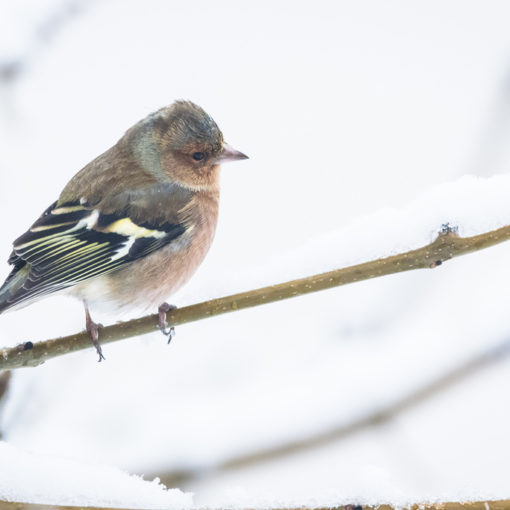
{"left": 0, "top": 100, "right": 248, "bottom": 361}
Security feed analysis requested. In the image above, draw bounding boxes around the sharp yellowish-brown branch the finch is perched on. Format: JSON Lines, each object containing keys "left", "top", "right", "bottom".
{"left": 0, "top": 221, "right": 510, "bottom": 370}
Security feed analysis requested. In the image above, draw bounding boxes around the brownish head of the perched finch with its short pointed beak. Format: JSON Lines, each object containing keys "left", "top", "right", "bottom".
{"left": 129, "top": 101, "right": 248, "bottom": 189}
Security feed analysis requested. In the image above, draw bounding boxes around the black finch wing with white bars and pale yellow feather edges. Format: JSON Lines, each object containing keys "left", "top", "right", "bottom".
{"left": 0, "top": 194, "right": 186, "bottom": 312}
